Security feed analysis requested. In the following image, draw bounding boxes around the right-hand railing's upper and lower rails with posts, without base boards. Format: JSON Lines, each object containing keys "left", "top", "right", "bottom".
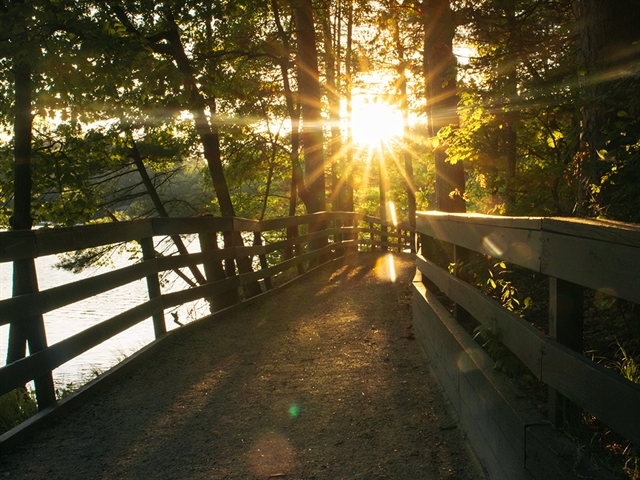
{"left": 416, "top": 212, "right": 640, "bottom": 445}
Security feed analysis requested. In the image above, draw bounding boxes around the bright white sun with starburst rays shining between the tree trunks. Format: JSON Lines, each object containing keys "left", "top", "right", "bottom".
{"left": 344, "top": 94, "right": 403, "bottom": 148}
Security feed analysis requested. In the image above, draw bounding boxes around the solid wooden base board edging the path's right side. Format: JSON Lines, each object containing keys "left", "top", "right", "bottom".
{"left": 413, "top": 282, "right": 544, "bottom": 480}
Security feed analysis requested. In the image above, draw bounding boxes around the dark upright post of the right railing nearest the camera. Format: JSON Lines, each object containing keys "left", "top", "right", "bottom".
{"left": 549, "top": 277, "right": 584, "bottom": 427}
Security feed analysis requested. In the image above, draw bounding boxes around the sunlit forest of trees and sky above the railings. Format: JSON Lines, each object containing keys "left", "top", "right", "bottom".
{"left": 0, "top": 0, "right": 640, "bottom": 229}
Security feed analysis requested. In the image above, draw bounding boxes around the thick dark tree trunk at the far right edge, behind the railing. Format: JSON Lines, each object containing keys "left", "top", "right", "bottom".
{"left": 573, "top": 0, "right": 640, "bottom": 220}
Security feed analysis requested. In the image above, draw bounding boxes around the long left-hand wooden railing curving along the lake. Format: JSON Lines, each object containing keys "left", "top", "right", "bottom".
{"left": 0, "top": 212, "right": 413, "bottom": 409}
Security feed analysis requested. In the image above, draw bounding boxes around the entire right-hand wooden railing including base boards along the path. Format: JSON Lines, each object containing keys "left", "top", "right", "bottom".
{"left": 414, "top": 212, "right": 640, "bottom": 478}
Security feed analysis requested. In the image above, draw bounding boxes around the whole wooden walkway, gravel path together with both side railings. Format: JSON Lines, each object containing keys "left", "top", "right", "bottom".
{"left": 0, "top": 213, "right": 640, "bottom": 479}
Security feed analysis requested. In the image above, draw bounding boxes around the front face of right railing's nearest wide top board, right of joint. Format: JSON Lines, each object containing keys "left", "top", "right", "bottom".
{"left": 540, "top": 232, "right": 640, "bottom": 303}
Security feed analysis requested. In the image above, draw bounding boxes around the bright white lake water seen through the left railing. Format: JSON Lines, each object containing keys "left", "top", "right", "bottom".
{"left": 0, "top": 242, "right": 208, "bottom": 386}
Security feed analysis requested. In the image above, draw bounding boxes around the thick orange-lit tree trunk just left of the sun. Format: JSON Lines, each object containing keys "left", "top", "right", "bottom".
{"left": 295, "top": 0, "right": 326, "bottom": 213}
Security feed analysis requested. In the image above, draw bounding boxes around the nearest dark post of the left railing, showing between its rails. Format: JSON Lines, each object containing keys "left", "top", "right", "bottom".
{"left": 7, "top": 258, "right": 56, "bottom": 410}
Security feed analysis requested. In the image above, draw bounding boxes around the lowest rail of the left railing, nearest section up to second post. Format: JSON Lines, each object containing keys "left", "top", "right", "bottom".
{"left": 0, "top": 298, "right": 162, "bottom": 395}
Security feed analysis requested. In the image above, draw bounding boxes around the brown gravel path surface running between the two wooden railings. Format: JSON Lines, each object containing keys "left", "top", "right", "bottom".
{"left": 0, "top": 254, "right": 484, "bottom": 479}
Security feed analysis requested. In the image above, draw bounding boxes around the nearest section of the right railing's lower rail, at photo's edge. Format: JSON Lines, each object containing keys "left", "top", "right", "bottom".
{"left": 541, "top": 340, "right": 640, "bottom": 445}
